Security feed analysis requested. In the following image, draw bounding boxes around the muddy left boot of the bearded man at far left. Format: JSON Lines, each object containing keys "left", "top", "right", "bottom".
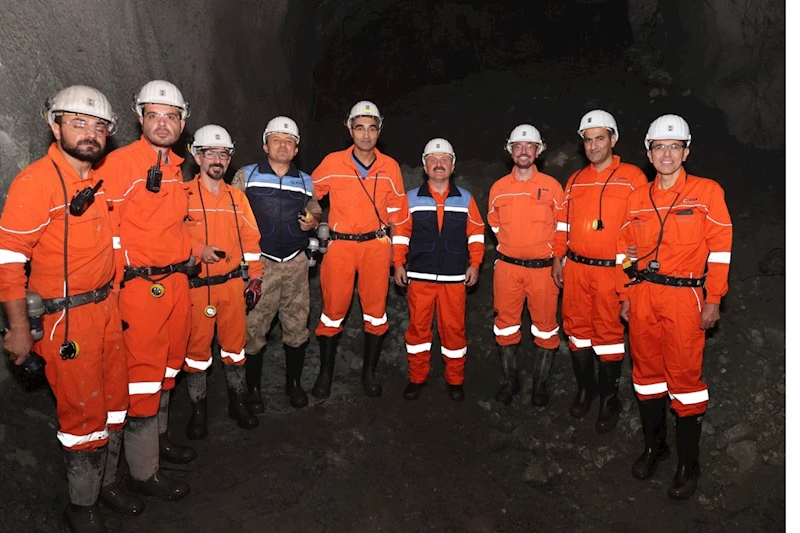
{"left": 62, "top": 447, "right": 108, "bottom": 533}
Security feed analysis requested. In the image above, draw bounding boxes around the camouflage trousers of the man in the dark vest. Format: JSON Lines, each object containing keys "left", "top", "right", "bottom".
{"left": 245, "top": 252, "right": 310, "bottom": 354}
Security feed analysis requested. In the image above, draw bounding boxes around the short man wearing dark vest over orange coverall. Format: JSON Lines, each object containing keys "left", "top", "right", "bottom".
{"left": 392, "top": 138, "right": 484, "bottom": 402}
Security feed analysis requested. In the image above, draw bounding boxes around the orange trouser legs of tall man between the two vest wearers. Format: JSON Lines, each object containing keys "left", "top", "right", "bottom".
{"left": 316, "top": 237, "right": 391, "bottom": 337}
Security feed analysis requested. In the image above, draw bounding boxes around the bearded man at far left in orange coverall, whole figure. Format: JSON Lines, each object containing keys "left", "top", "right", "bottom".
{"left": 0, "top": 85, "right": 134, "bottom": 533}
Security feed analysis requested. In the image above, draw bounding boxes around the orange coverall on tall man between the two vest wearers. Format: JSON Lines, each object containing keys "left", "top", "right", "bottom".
{"left": 311, "top": 146, "right": 405, "bottom": 337}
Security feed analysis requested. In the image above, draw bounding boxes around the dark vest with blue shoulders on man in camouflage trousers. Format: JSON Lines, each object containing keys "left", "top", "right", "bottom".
{"left": 244, "top": 158, "right": 312, "bottom": 262}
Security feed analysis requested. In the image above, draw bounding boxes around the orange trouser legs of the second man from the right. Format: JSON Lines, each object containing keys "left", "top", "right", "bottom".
{"left": 561, "top": 259, "right": 625, "bottom": 361}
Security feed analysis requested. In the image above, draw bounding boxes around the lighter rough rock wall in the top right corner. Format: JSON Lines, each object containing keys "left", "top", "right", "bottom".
{"left": 628, "top": 0, "right": 786, "bottom": 150}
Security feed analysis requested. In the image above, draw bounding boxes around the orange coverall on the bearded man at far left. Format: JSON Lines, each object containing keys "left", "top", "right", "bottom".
{"left": 0, "top": 143, "right": 128, "bottom": 451}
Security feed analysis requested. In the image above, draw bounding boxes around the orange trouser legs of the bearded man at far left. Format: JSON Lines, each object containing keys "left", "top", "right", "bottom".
{"left": 33, "top": 293, "right": 128, "bottom": 451}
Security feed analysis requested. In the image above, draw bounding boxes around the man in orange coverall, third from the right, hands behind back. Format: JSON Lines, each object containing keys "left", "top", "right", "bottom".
{"left": 487, "top": 124, "right": 564, "bottom": 406}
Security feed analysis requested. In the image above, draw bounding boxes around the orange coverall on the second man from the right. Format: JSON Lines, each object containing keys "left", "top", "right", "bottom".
{"left": 555, "top": 155, "right": 647, "bottom": 361}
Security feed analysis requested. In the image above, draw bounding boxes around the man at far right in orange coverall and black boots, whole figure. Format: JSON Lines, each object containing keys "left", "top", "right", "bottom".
{"left": 617, "top": 115, "right": 733, "bottom": 500}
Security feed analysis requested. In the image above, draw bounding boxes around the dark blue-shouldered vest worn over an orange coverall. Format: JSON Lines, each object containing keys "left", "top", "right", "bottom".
{"left": 406, "top": 183, "right": 472, "bottom": 283}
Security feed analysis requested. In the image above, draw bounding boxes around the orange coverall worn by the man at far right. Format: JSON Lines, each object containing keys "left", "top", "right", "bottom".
{"left": 617, "top": 169, "right": 733, "bottom": 416}
